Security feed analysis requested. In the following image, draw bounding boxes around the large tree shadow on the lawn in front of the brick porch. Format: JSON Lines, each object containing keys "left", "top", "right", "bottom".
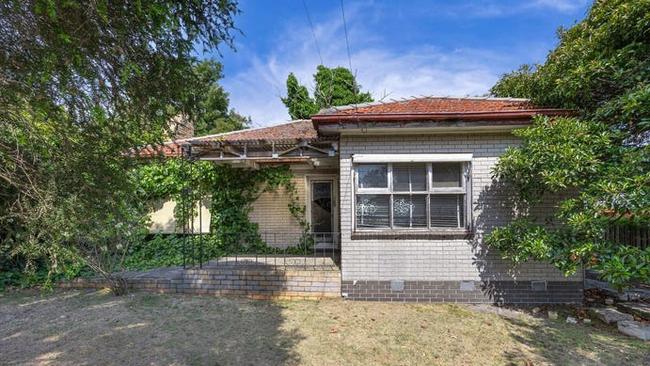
{"left": 0, "top": 291, "right": 302, "bottom": 365}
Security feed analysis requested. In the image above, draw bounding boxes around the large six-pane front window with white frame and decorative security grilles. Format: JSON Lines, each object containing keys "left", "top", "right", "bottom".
{"left": 354, "top": 162, "right": 469, "bottom": 230}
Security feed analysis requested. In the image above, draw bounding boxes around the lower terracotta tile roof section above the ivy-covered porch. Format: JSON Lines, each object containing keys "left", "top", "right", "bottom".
{"left": 138, "top": 120, "right": 318, "bottom": 157}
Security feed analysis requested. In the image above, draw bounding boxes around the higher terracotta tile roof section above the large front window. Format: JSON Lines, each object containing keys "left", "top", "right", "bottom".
{"left": 312, "top": 97, "right": 568, "bottom": 124}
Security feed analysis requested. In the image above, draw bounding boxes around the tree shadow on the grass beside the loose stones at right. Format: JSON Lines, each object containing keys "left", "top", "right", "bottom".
{"left": 504, "top": 317, "right": 650, "bottom": 365}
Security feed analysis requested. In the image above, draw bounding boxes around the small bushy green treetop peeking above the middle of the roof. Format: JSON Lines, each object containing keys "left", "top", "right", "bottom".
{"left": 282, "top": 65, "right": 373, "bottom": 119}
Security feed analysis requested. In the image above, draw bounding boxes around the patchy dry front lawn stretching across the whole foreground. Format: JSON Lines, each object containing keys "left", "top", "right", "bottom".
{"left": 0, "top": 290, "right": 650, "bottom": 365}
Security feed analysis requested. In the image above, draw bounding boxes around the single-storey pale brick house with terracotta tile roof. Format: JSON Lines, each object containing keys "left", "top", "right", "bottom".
{"left": 144, "top": 97, "right": 583, "bottom": 303}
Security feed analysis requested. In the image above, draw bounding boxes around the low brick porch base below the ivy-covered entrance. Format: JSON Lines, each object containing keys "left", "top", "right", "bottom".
{"left": 60, "top": 266, "right": 341, "bottom": 299}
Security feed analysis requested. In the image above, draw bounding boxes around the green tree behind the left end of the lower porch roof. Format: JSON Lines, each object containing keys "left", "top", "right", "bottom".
{"left": 187, "top": 60, "right": 250, "bottom": 136}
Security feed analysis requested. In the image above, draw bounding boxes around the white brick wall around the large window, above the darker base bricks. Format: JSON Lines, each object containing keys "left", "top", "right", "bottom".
{"left": 340, "top": 133, "right": 582, "bottom": 281}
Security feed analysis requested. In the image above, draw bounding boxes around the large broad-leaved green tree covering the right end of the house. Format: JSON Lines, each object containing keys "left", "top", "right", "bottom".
{"left": 486, "top": 0, "right": 650, "bottom": 287}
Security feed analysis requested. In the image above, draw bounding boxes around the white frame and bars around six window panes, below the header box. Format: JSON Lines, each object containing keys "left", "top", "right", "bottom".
{"left": 352, "top": 159, "right": 472, "bottom": 234}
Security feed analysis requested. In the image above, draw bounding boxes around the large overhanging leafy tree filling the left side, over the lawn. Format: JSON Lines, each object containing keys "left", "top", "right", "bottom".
{"left": 0, "top": 0, "right": 237, "bottom": 293}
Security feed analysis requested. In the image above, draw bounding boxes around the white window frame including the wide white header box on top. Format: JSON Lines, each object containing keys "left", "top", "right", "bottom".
{"left": 352, "top": 154, "right": 472, "bottom": 233}
